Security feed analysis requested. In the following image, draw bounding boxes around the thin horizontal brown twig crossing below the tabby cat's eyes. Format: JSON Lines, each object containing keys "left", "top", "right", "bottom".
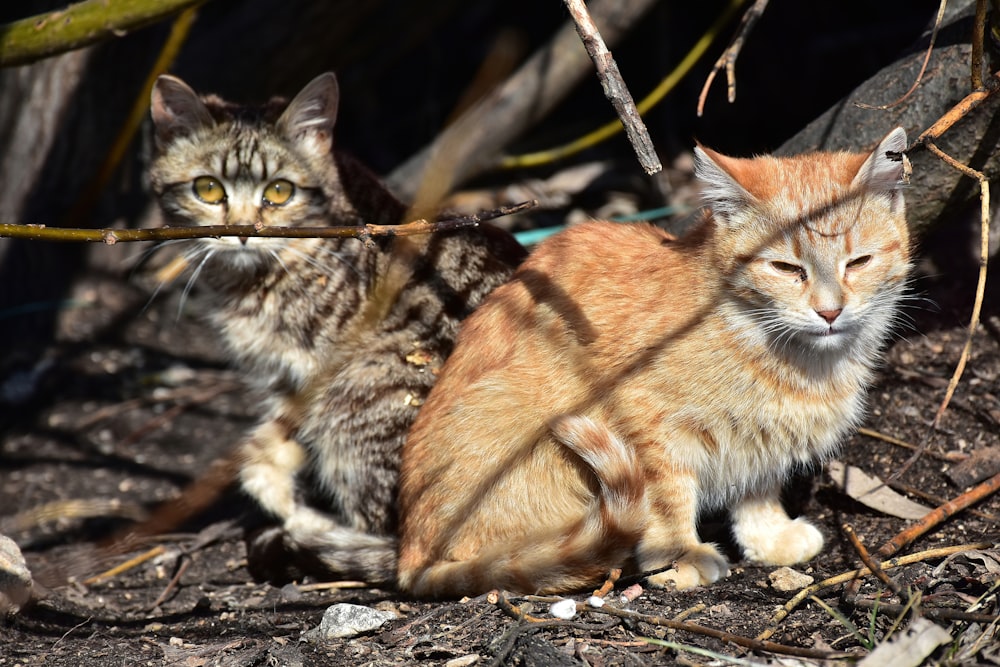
{"left": 0, "top": 200, "right": 538, "bottom": 245}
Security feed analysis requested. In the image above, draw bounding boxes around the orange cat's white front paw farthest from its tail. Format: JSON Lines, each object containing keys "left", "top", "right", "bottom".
{"left": 731, "top": 488, "right": 823, "bottom": 565}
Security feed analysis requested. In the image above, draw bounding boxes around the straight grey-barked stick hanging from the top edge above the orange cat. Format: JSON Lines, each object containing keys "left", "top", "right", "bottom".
{"left": 564, "top": 0, "right": 663, "bottom": 175}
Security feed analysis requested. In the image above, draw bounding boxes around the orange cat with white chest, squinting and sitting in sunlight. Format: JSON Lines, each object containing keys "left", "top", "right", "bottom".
{"left": 398, "top": 129, "right": 909, "bottom": 596}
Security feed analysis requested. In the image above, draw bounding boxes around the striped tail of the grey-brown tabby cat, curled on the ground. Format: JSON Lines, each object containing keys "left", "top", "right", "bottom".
{"left": 247, "top": 508, "right": 397, "bottom": 586}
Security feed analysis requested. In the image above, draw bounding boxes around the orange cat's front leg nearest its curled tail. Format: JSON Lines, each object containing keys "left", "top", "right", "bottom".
{"left": 636, "top": 469, "right": 729, "bottom": 590}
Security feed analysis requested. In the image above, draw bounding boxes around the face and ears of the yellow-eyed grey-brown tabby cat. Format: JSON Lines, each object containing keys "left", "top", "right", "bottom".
{"left": 151, "top": 76, "right": 337, "bottom": 266}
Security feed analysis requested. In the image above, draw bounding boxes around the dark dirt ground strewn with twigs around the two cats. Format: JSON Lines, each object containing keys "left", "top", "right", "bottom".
{"left": 0, "top": 201, "right": 1000, "bottom": 667}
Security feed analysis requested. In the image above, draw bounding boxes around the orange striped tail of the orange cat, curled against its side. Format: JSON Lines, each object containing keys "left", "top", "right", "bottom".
{"left": 399, "top": 416, "right": 648, "bottom": 597}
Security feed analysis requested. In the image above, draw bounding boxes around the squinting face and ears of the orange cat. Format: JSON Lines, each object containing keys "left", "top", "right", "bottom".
{"left": 698, "top": 130, "right": 909, "bottom": 356}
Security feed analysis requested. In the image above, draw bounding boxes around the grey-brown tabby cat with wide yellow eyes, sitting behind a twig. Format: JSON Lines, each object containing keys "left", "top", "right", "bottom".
{"left": 150, "top": 73, "right": 524, "bottom": 583}
